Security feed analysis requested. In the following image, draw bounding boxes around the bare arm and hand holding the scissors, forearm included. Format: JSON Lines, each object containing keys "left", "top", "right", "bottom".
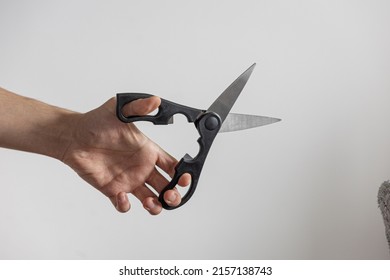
{"left": 0, "top": 88, "right": 191, "bottom": 215}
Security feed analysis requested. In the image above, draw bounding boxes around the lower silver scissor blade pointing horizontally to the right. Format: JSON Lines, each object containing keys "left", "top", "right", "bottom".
{"left": 219, "top": 113, "right": 281, "bottom": 132}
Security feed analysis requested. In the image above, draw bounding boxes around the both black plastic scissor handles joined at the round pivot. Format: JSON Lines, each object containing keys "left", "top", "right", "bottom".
{"left": 117, "top": 93, "right": 222, "bottom": 210}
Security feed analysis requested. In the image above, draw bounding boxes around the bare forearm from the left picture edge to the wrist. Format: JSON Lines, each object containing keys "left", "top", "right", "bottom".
{"left": 0, "top": 88, "right": 79, "bottom": 160}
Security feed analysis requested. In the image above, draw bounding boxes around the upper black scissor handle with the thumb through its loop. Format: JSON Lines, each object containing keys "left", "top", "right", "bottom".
{"left": 116, "top": 93, "right": 203, "bottom": 125}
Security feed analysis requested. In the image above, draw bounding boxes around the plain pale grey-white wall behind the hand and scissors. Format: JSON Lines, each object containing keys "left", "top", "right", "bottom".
{"left": 0, "top": 0, "right": 390, "bottom": 259}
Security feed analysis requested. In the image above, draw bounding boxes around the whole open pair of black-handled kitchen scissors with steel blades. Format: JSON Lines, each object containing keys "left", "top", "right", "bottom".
{"left": 116, "top": 63, "right": 280, "bottom": 210}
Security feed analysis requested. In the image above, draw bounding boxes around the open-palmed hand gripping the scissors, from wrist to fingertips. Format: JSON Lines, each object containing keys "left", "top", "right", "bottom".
{"left": 62, "top": 96, "right": 191, "bottom": 215}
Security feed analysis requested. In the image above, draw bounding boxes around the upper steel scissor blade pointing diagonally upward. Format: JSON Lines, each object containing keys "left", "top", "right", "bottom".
{"left": 208, "top": 63, "right": 256, "bottom": 123}
